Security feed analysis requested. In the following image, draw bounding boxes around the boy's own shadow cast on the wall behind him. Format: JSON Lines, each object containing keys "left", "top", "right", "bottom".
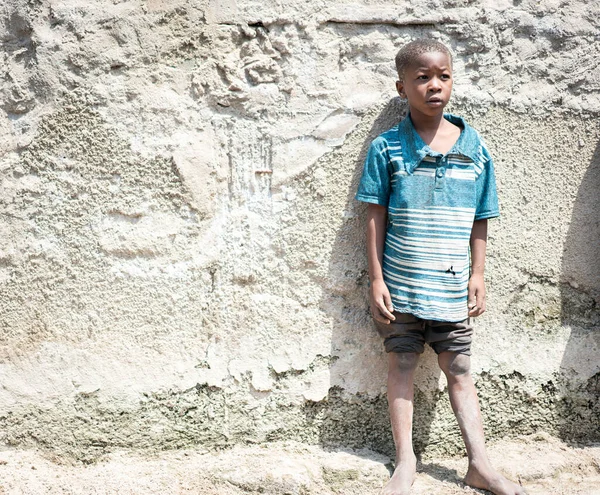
{"left": 305, "top": 97, "right": 440, "bottom": 462}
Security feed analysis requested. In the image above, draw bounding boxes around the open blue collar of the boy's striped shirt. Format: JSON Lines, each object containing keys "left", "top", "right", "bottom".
{"left": 398, "top": 113, "right": 480, "bottom": 174}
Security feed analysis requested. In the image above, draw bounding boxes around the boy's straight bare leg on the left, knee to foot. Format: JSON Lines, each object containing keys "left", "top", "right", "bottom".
{"left": 381, "top": 352, "right": 419, "bottom": 495}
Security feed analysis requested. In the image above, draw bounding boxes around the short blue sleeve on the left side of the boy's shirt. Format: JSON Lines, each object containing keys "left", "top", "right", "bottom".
{"left": 356, "top": 137, "right": 390, "bottom": 206}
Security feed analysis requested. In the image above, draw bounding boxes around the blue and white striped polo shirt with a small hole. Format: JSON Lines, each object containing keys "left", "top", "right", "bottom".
{"left": 356, "top": 114, "right": 499, "bottom": 322}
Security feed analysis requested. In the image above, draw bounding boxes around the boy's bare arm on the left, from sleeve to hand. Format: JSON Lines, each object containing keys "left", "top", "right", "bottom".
{"left": 367, "top": 204, "right": 396, "bottom": 324}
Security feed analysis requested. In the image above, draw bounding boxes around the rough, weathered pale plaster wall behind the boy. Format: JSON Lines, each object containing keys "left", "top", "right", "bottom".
{"left": 0, "top": 0, "right": 600, "bottom": 460}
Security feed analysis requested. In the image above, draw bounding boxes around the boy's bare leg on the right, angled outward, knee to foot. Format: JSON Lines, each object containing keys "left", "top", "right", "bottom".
{"left": 438, "top": 352, "right": 526, "bottom": 495}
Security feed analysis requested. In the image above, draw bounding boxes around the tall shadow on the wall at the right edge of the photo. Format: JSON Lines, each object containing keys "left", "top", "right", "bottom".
{"left": 558, "top": 139, "right": 600, "bottom": 441}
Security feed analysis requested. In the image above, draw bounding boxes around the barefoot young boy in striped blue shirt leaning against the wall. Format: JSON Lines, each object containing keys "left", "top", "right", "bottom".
{"left": 356, "top": 39, "right": 525, "bottom": 495}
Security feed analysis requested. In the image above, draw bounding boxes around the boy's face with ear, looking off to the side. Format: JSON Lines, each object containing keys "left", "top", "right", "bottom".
{"left": 396, "top": 52, "right": 452, "bottom": 117}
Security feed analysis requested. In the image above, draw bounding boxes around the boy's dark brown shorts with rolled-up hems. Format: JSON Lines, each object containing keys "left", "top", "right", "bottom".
{"left": 375, "top": 311, "right": 473, "bottom": 356}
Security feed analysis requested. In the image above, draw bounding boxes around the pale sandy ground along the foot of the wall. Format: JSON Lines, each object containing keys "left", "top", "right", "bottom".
{"left": 0, "top": 435, "right": 600, "bottom": 495}
